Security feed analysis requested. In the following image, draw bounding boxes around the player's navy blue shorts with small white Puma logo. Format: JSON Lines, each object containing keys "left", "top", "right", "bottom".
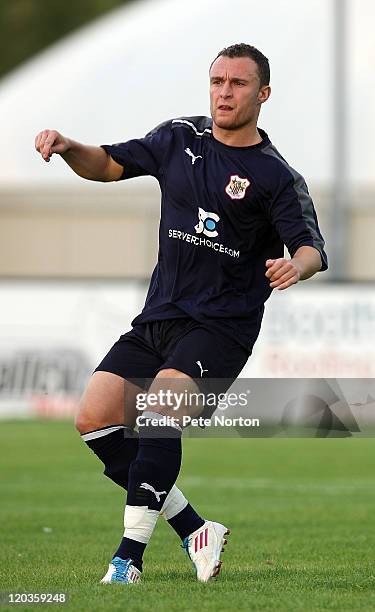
{"left": 95, "top": 317, "right": 250, "bottom": 414}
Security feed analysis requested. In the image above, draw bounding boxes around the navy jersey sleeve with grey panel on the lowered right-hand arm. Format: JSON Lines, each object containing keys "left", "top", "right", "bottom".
{"left": 268, "top": 167, "right": 328, "bottom": 271}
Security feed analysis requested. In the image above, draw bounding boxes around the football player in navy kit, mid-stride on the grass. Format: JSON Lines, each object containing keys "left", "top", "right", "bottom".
{"left": 35, "top": 44, "right": 327, "bottom": 583}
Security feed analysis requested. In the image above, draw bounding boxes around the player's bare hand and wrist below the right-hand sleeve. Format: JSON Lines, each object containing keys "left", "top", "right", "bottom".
{"left": 266, "top": 246, "right": 322, "bottom": 289}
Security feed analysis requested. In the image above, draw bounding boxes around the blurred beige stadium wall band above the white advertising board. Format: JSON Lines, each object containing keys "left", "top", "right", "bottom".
{"left": 0, "top": 182, "right": 375, "bottom": 281}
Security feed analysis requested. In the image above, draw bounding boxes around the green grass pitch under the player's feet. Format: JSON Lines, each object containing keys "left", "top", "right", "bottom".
{"left": 0, "top": 421, "right": 375, "bottom": 612}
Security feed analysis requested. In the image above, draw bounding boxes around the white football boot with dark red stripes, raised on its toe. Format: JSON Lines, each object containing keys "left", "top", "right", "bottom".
{"left": 182, "top": 521, "right": 230, "bottom": 582}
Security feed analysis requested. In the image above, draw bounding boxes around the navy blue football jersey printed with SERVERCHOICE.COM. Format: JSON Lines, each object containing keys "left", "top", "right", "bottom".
{"left": 103, "top": 117, "right": 327, "bottom": 350}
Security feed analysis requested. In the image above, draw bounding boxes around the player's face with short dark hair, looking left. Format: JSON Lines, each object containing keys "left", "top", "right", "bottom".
{"left": 210, "top": 56, "right": 270, "bottom": 130}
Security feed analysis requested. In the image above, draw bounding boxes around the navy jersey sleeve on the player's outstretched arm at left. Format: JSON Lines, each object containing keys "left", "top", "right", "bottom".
{"left": 101, "top": 121, "right": 172, "bottom": 181}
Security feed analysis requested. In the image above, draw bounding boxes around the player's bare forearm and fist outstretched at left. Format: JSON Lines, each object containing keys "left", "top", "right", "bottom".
{"left": 35, "top": 130, "right": 124, "bottom": 182}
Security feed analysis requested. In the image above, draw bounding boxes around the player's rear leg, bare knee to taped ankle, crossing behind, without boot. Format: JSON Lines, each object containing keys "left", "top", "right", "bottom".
{"left": 76, "top": 330, "right": 203, "bottom": 584}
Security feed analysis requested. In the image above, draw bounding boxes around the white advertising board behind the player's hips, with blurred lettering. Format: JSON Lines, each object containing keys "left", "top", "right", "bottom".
{"left": 0, "top": 281, "right": 375, "bottom": 418}
